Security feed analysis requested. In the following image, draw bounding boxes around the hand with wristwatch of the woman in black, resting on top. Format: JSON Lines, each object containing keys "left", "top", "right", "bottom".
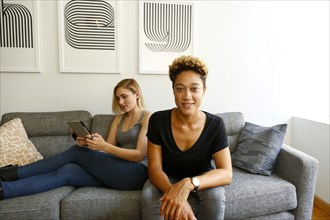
{"left": 159, "top": 178, "right": 192, "bottom": 220}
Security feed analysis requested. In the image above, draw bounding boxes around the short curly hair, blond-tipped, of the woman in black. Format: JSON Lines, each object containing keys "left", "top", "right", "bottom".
{"left": 169, "top": 55, "right": 208, "bottom": 87}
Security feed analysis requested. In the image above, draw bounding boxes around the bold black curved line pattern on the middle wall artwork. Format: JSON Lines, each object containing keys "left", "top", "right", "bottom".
{"left": 64, "top": 0, "right": 116, "bottom": 50}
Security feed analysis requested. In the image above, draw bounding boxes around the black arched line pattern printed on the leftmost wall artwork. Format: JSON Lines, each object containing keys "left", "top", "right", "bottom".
{"left": 0, "top": 0, "right": 33, "bottom": 48}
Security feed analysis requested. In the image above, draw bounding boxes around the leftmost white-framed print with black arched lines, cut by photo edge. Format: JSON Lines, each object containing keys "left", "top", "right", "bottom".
{"left": 0, "top": 0, "right": 41, "bottom": 73}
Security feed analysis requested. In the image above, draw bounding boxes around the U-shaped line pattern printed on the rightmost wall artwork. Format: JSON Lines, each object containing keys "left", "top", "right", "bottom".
{"left": 143, "top": 2, "right": 192, "bottom": 52}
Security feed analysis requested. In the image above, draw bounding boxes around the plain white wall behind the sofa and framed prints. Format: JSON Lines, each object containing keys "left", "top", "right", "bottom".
{"left": 0, "top": 0, "right": 329, "bottom": 197}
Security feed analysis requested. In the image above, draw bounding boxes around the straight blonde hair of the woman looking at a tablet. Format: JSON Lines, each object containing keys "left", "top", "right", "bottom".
{"left": 112, "top": 79, "right": 145, "bottom": 114}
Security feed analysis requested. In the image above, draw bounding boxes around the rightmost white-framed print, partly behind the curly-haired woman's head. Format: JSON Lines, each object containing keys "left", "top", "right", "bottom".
{"left": 139, "top": 0, "right": 197, "bottom": 74}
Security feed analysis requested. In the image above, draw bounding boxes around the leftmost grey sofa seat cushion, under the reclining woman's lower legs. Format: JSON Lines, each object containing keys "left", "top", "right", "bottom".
{"left": 0, "top": 186, "right": 74, "bottom": 220}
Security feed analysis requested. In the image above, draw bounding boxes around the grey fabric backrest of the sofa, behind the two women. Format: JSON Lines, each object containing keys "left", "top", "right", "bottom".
{"left": 0, "top": 110, "right": 245, "bottom": 157}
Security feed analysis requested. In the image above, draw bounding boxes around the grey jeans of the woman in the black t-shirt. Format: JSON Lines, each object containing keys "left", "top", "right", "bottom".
{"left": 142, "top": 177, "right": 225, "bottom": 220}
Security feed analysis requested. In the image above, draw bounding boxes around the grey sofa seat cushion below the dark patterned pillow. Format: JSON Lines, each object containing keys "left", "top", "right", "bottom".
{"left": 225, "top": 168, "right": 297, "bottom": 219}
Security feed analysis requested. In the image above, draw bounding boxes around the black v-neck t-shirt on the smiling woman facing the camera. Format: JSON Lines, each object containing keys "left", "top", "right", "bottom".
{"left": 147, "top": 109, "right": 228, "bottom": 178}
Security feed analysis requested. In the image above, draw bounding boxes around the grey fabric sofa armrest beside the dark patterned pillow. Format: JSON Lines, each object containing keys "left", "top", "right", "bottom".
{"left": 275, "top": 145, "right": 319, "bottom": 220}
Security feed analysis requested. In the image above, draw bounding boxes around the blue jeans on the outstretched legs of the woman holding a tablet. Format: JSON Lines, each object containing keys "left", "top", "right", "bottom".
{"left": 1, "top": 146, "right": 148, "bottom": 199}
